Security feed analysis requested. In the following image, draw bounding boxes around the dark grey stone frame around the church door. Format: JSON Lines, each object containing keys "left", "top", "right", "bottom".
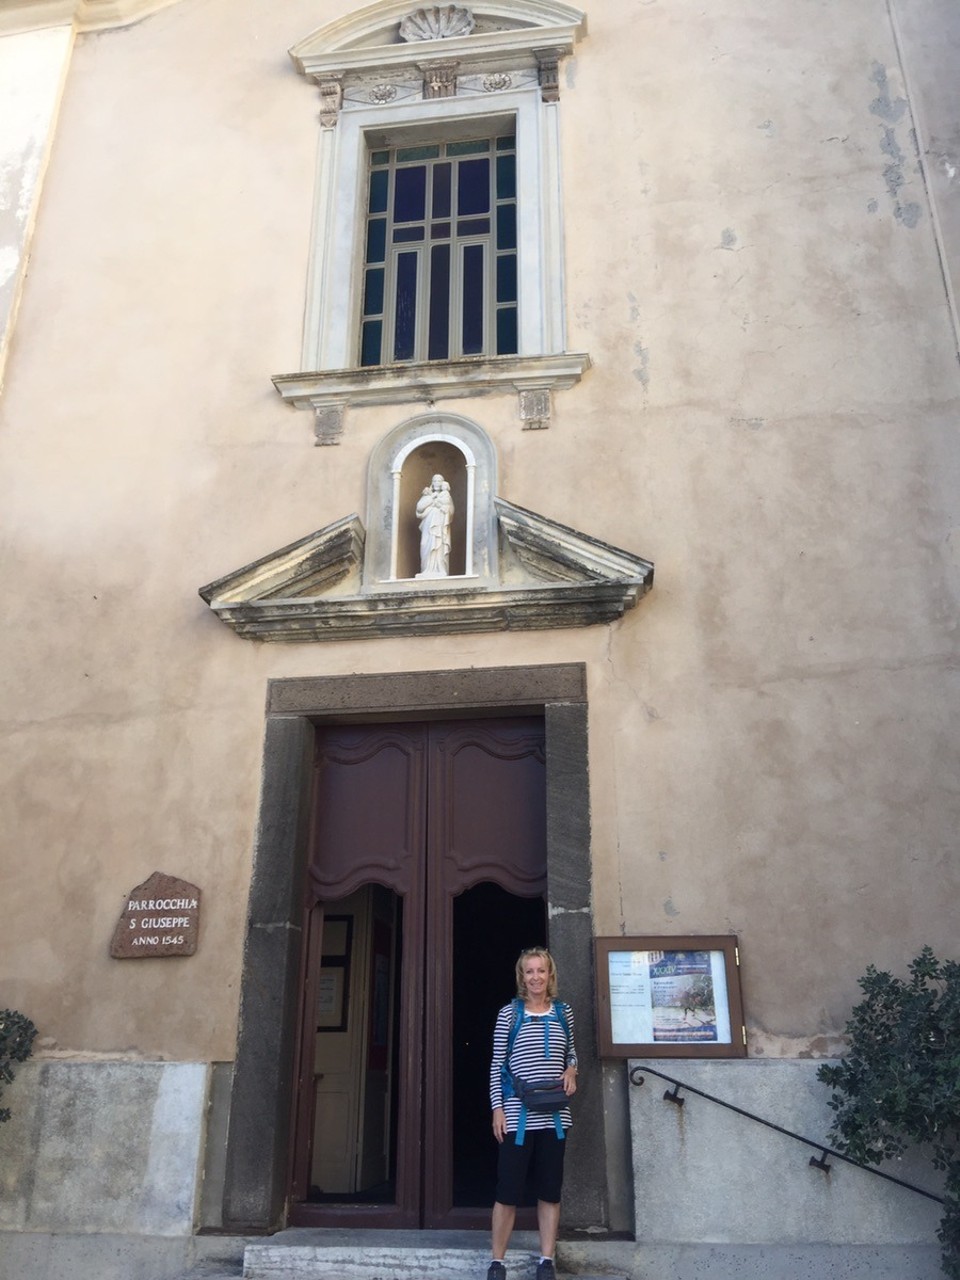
{"left": 223, "top": 663, "right": 609, "bottom": 1233}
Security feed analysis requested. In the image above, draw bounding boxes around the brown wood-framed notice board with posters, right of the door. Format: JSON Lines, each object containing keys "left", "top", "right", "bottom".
{"left": 594, "top": 934, "right": 746, "bottom": 1057}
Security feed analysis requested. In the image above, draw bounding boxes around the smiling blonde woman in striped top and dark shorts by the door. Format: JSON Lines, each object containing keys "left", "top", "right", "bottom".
{"left": 486, "top": 947, "right": 577, "bottom": 1280}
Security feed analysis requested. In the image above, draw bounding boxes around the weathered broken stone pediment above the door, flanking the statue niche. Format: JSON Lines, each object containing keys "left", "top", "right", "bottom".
{"left": 200, "top": 498, "right": 653, "bottom": 643}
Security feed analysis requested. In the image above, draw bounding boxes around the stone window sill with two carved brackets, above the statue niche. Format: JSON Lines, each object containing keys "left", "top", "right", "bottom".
{"left": 273, "top": 352, "right": 590, "bottom": 444}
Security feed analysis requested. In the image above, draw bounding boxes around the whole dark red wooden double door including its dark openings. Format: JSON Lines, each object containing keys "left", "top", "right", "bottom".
{"left": 289, "top": 717, "right": 547, "bottom": 1228}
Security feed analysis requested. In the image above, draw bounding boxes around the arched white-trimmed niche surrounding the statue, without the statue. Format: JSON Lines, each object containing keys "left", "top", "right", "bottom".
{"left": 364, "top": 413, "right": 498, "bottom": 591}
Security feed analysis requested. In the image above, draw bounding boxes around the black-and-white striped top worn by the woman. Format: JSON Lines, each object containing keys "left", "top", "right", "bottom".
{"left": 490, "top": 1001, "right": 577, "bottom": 1133}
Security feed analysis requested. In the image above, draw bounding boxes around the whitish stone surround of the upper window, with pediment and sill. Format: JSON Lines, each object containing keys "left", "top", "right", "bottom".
{"left": 268, "top": 0, "right": 590, "bottom": 443}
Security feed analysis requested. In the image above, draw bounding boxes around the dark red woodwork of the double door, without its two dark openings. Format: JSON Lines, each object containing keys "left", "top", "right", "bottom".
{"left": 291, "top": 717, "right": 547, "bottom": 1226}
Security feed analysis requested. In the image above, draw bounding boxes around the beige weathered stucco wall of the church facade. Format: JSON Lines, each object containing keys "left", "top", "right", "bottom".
{"left": 0, "top": 0, "right": 960, "bottom": 1061}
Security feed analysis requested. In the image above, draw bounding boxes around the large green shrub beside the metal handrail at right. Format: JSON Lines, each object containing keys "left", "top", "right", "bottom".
{"left": 817, "top": 947, "right": 960, "bottom": 1280}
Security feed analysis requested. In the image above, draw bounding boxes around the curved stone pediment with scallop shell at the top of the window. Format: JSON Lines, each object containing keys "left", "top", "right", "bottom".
{"left": 291, "top": 0, "right": 585, "bottom": 76}
